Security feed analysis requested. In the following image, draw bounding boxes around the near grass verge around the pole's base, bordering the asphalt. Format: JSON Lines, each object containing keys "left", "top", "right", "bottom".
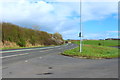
{"left": 62, "top": 41, "right": 119, "bottom": 59}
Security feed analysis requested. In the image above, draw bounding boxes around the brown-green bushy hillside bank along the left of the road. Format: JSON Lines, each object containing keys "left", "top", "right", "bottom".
{"left": 0, "top": 23, "right": 63, "bottom": 48}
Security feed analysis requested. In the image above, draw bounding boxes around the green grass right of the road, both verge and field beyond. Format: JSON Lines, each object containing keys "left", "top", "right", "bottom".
{"left": 62, "top": 40, "right": 119, "bottom": 59}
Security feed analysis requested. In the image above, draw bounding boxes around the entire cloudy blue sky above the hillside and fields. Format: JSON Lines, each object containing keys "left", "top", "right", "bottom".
{"left": 0, "top": 0, "right": 120, "bottom": 39}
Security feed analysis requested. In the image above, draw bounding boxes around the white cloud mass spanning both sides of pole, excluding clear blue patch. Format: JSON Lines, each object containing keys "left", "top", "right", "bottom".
{"left": 0, "top": 0, "right": 117, "bottom": 39}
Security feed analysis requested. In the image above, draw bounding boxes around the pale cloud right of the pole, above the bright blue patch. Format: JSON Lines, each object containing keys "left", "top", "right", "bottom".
{"left": 82, "top": 2, "right": 118, "bottom": 21}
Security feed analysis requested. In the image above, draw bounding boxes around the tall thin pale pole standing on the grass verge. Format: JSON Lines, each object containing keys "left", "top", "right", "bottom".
{"left": 79, "top": 0, "right": 82, "bottom": 53}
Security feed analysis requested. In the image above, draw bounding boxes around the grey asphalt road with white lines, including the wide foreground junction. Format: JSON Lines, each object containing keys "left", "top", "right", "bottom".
{"left": 0, "top": 44, "right": 118, "bottom": 78}
